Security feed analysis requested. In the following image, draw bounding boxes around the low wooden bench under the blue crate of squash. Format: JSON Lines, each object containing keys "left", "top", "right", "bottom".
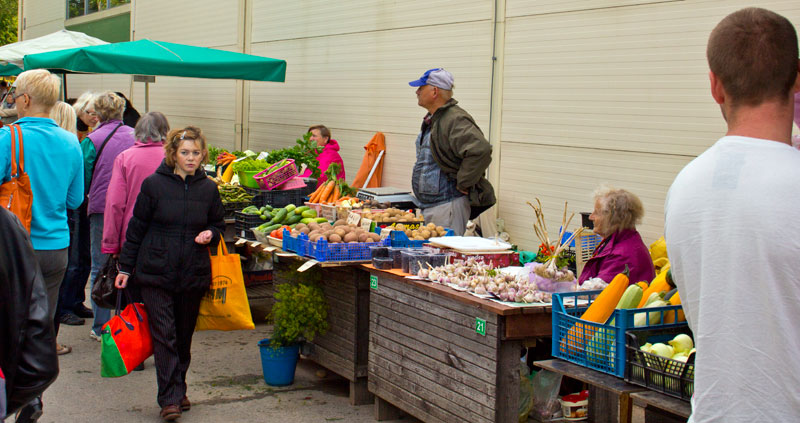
{"left": 533, "top": 359, "right": 646, "bottom": 423}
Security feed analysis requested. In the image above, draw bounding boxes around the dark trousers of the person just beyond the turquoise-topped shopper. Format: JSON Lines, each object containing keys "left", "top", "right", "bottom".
{"left": 55, "top": 207, "right": 92, "bottom": 333}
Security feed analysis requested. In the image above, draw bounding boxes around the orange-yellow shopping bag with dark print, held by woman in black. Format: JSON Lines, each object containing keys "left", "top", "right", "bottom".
{"left": 195, "top": 240, "right": 256, "bottom": 331}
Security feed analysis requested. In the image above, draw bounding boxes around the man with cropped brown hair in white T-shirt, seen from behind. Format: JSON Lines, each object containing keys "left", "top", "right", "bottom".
{"left": 665, "top": 8, "right": 800, "bottom": 423}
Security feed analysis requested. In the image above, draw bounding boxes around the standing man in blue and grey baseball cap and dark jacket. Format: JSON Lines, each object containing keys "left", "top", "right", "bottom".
{"left": 408, "top": 68, "right": 497, "bottom": 235}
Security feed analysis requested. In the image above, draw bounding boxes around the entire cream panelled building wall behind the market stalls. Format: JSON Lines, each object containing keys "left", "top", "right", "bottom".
{"left": 17, "top": 0, "right": 800, "bottom": 249}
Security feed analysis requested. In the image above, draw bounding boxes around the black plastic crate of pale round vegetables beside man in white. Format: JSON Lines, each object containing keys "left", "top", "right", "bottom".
{"left": 625, "top": 328, "right": 695, "bottom": 401}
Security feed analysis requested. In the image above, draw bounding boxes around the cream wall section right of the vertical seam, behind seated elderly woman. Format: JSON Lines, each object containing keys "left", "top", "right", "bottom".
{"left": 499, "top": 0, "right": 800, "bottom": 248}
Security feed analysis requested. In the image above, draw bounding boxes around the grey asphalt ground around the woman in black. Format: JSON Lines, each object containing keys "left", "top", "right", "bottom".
{"left": 32, "top": 300, "right": 416, "bottom": 423}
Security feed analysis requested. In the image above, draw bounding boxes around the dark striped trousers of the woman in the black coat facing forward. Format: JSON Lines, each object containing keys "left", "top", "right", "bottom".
{"left": 140, "top": 286, "right": 204, "bottom": 407}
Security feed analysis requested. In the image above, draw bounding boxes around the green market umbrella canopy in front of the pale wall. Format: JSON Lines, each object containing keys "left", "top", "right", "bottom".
{"left": 24, "top": 39, "right": 286, "bottom": 82}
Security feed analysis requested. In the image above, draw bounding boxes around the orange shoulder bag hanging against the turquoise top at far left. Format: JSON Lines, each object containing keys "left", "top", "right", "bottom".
{"left": 0, "top": 125, "right": 33, "bottom": 232}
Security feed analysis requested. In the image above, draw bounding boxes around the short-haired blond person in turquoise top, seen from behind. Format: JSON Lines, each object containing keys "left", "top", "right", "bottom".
{"left": 0, "top": 69, "right": 83, "bottom": 422}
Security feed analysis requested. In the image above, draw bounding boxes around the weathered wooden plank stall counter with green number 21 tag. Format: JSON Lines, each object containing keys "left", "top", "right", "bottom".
{"left": 365, "top": 266, "right": 550, "bottom": 423}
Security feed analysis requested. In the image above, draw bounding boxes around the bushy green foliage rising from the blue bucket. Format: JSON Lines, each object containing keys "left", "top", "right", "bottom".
{"left": 268, "top": 269, "right": 329, "bottom": 348}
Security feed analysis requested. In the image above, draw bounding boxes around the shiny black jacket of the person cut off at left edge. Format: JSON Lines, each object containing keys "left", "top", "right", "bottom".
{"left": 0, "top": 207, "right": 58, "bottom": 421}
